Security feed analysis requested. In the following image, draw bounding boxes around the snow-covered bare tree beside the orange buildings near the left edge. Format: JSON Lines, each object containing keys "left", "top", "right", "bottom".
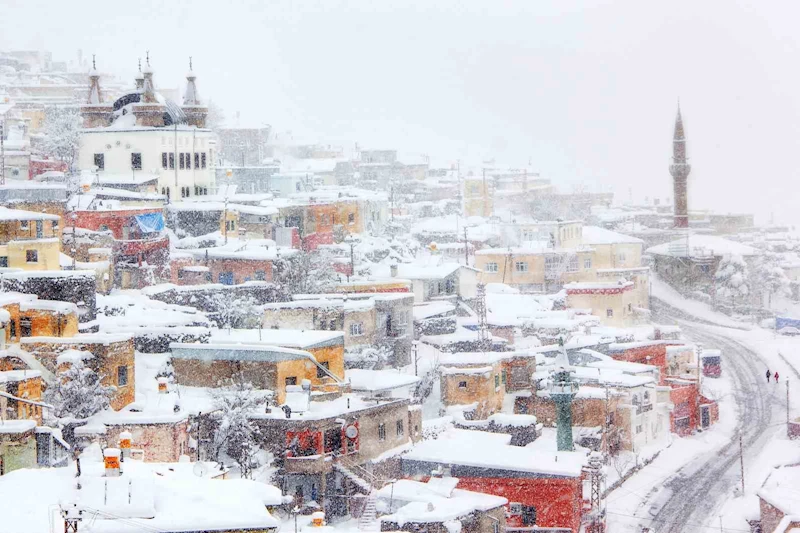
{"left": 44, "top": 360, "right": 116, "bottom": 420}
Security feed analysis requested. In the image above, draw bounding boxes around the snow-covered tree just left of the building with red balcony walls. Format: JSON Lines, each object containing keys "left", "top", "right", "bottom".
{"left": 212, "top": 375, "right": 267, "bottom": 478}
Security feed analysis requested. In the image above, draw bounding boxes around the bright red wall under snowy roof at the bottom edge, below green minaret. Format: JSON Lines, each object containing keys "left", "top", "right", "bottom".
{"left": 458, "top": 476, "right": 583, "bottom": 533}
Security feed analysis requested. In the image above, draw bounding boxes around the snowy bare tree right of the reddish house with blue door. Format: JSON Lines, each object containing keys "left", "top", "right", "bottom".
{"left": 272, "top": 249, "right": 339, "bottom": 294}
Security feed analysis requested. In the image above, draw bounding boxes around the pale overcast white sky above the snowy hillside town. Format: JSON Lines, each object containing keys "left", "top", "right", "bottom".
{"left": 0, "top": 0, "right": 800, "bottom": 223}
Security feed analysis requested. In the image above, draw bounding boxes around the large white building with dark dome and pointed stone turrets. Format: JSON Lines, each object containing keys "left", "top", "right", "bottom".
{"left": 78, "top": 56, "right": 216, "bottom": 200}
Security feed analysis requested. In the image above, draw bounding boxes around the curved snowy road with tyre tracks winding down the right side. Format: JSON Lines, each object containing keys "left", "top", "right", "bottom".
{"left": 650, "top": 298, "right": 775, "bottom": 533}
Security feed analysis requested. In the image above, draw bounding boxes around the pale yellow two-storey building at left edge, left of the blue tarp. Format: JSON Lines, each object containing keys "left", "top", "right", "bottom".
{"left": 0, "top": 207, "right": 61, "bottom": 270}
